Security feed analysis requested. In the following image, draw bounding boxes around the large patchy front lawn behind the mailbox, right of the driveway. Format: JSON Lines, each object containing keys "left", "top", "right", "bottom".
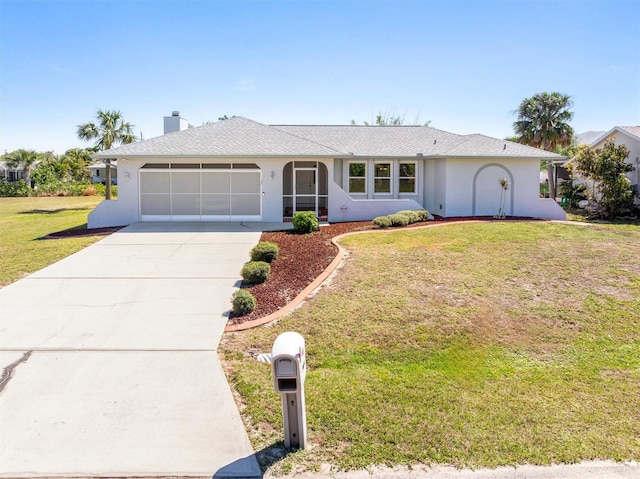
{"left": 221, "top": 222, "right": 640, "bottom": 470}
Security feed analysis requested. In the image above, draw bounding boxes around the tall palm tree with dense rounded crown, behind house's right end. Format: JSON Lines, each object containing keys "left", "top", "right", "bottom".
{"left": 513, "top": 92, "right": 573, "bottom": 198}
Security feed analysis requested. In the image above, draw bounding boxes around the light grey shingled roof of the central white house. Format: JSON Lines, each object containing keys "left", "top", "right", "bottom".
{"left": 94, "top": 117, "right": 562, "bottom": 159}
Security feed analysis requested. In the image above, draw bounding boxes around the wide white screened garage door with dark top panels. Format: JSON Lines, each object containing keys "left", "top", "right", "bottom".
{"left": 140, "top": 163, "right": 262, "bottom": 221}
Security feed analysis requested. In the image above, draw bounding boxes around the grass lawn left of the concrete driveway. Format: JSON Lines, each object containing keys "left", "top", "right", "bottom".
{"left": 0, "top": 196, "right": 104, "bottom": 286}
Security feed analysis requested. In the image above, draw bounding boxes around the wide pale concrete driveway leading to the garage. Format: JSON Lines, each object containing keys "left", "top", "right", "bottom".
{"left": 0, "top": 223, "right": 277, "bottom": 477}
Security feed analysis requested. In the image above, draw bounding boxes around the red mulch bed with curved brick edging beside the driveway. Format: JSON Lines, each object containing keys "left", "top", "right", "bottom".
{"left": 229, "top": 216, "right": 531, "bottom": 324}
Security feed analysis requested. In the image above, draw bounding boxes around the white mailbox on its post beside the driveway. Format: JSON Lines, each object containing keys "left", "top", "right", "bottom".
{"left": 271, "top": 332, "right": 307, "bottom": 449}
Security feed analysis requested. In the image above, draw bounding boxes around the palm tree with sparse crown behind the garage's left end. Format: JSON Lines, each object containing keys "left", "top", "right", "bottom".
{"left": 78, "top": 110, "right": 136, "bottom": 200}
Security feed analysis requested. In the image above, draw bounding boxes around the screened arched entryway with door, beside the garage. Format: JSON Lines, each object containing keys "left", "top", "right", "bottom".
{"left": 282, "top": 161, "right": 329, "bottom": 221}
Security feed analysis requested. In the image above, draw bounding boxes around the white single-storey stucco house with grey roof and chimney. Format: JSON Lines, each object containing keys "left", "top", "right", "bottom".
{"left": 89, "top": 112, "right": 565, "bottom": 227}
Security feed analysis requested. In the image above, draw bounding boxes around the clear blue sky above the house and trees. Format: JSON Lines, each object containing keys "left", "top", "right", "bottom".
{"left": 0, "top": 0, "right": 640, "bottom": 153}
